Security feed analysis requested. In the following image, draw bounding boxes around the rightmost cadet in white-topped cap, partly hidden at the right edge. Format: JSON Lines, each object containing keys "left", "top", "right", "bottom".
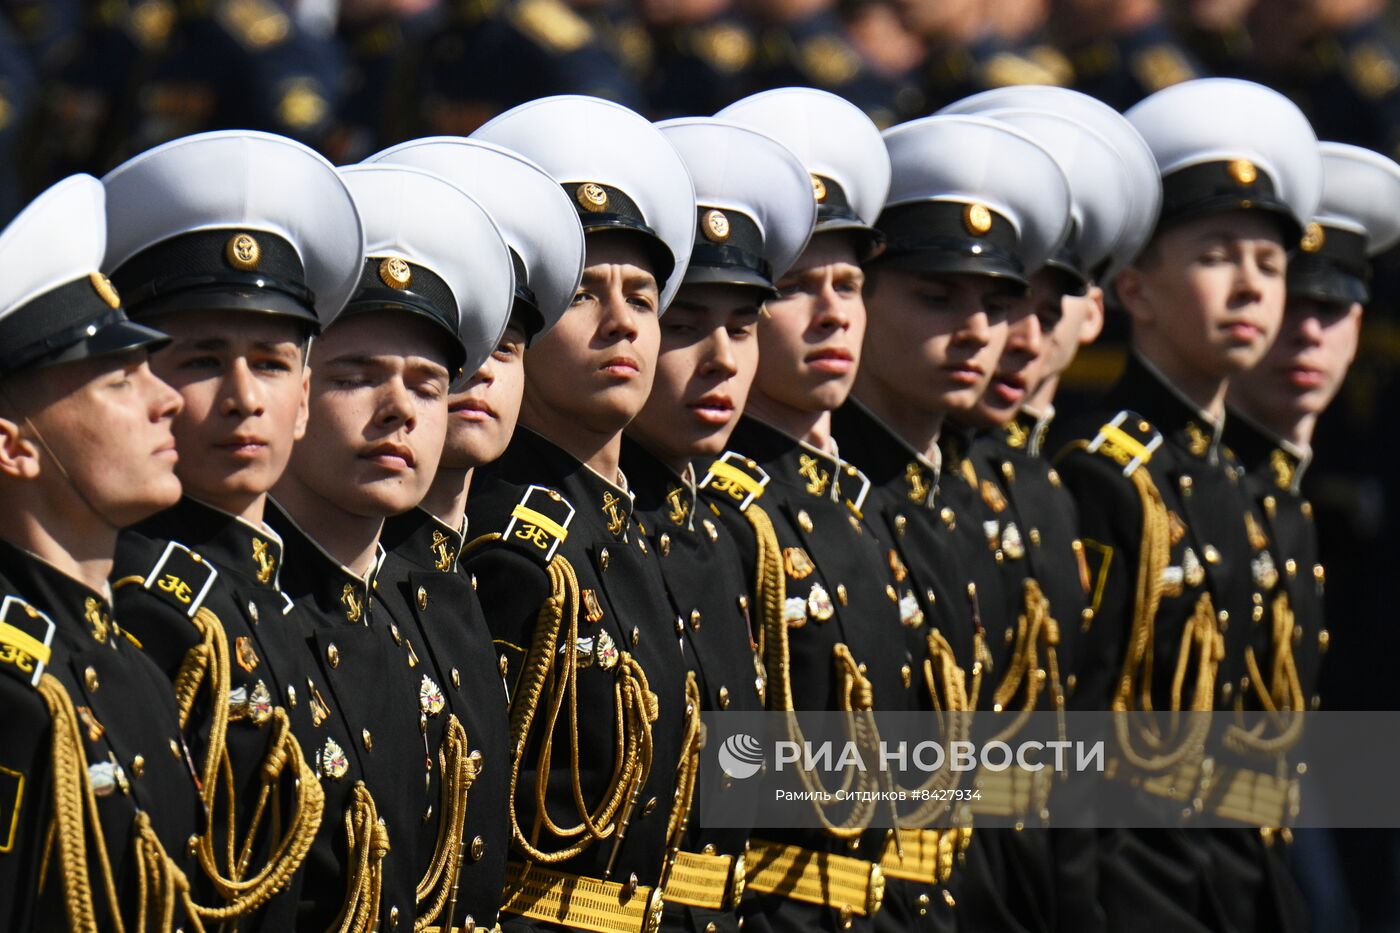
{"left": 1225, "top": 143, "right": 1400, "bottom": 709}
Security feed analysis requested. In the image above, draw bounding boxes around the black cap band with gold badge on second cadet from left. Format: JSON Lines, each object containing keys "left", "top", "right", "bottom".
{"left": 112, "top": 228, "right": 318, "bottom": 325}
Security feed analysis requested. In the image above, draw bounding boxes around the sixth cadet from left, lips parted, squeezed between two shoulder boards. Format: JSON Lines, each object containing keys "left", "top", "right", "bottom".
{"left": 622, "top": 118, "right": 816, "bottom": 932}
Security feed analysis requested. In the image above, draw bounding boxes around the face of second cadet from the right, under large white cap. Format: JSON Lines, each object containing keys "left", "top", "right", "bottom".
{"left": 1120, "top": 213, "right": 1288, "bottom": 378}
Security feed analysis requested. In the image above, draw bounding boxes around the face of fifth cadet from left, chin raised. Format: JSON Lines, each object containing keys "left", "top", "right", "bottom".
{"left": 525, "top": 233, "right": 661, "bottom": 434}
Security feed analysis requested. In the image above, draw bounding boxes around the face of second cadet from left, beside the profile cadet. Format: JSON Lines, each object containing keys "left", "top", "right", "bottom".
{"left": 151, "top": 314, "right": 308, "bottom": 514}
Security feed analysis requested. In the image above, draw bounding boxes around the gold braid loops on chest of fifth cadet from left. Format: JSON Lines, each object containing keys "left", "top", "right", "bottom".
{"left": 510, "top": 555, "right": 658, "bottom": 864}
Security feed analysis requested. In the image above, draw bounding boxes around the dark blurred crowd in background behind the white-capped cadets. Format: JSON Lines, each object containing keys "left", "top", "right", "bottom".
{"left": 0, "top": 0, "right": 1400, "bottom": 930}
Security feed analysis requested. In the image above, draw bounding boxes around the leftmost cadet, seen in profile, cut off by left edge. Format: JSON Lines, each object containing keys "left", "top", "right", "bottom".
{"left": 0, "top": 175, "right": 204, "bottom": 933}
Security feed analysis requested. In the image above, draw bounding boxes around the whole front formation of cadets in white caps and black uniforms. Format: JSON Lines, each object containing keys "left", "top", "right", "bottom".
{"left": 0, "top": 70, "right": 1400, "bottom": 933}
